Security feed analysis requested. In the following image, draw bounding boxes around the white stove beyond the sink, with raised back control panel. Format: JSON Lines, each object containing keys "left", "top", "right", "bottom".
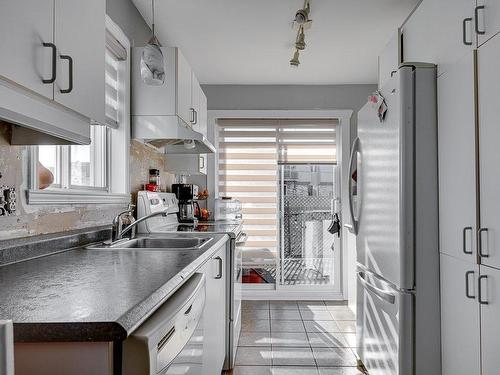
{"left": 137, "top": 191, "right": 247, "bottom": 370}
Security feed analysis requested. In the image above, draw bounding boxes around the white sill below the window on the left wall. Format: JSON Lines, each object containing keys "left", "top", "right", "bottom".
{"left": 27, "top": 189, "right": 130, "bottom": 205}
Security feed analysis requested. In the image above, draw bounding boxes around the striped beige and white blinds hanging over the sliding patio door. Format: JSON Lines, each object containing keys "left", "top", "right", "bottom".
{"left": 217, "top": 119, "right": 338, "bottom": 251}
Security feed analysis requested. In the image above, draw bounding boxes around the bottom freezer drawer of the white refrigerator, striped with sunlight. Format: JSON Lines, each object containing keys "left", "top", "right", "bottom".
{"left": 357, "top": 268, "right": 414, "bottom": 375}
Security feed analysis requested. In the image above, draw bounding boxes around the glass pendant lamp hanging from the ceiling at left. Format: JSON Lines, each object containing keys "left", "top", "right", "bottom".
{"left": 141, "top": 0, "right": 165, "bottom": 86}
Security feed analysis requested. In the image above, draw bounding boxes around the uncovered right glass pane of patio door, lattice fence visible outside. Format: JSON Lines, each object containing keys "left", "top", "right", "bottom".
{"left": 278, "top": 163, "right": 340, "bottom": 287}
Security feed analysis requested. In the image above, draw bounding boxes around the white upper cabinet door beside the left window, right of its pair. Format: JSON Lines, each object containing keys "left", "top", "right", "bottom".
{"left": 54, "top": 0, "right": 106, "bottom": 124}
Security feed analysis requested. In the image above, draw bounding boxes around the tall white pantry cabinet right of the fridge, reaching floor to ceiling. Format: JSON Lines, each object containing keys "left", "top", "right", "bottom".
{"left": 402, "top": 0, "right": 500, "bottom": 375}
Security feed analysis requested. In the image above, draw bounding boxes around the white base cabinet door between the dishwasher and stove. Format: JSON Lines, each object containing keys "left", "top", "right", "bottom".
{"left": 203, "top": 246, "right": 227, "bottom": 374}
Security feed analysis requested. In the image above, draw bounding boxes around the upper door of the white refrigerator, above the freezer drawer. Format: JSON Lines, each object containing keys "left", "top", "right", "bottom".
{"left": 356, "top": 69, "right": 413, "bottom": 289}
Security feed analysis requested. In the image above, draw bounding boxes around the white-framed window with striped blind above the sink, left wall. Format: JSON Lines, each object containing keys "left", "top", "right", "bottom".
{"left": 28, "top": 17, "right": 130, "bottom": 204}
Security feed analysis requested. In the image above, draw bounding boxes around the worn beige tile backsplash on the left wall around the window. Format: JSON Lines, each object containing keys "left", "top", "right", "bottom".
{"left": 0, "top": 122, "right": 174, "bottom": 240}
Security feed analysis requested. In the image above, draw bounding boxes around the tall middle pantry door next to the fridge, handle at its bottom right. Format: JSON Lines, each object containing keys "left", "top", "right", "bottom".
{"left": 437, "top": 52, "right": 476, "bottom": 262}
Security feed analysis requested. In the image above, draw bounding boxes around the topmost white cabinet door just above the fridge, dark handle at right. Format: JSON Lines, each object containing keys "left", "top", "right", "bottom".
{"left": 403, "top": 0, "right": 475, "bottom": 74}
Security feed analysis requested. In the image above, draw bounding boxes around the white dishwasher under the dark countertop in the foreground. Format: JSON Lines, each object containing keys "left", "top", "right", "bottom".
{"left": 123, "top": 273, "right": 206, "bottom": 375}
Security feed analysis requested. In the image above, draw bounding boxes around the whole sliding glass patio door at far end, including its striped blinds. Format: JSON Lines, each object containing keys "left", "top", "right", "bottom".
{"left": 218, "top": 119, "right": 340, "bottom": 291}
